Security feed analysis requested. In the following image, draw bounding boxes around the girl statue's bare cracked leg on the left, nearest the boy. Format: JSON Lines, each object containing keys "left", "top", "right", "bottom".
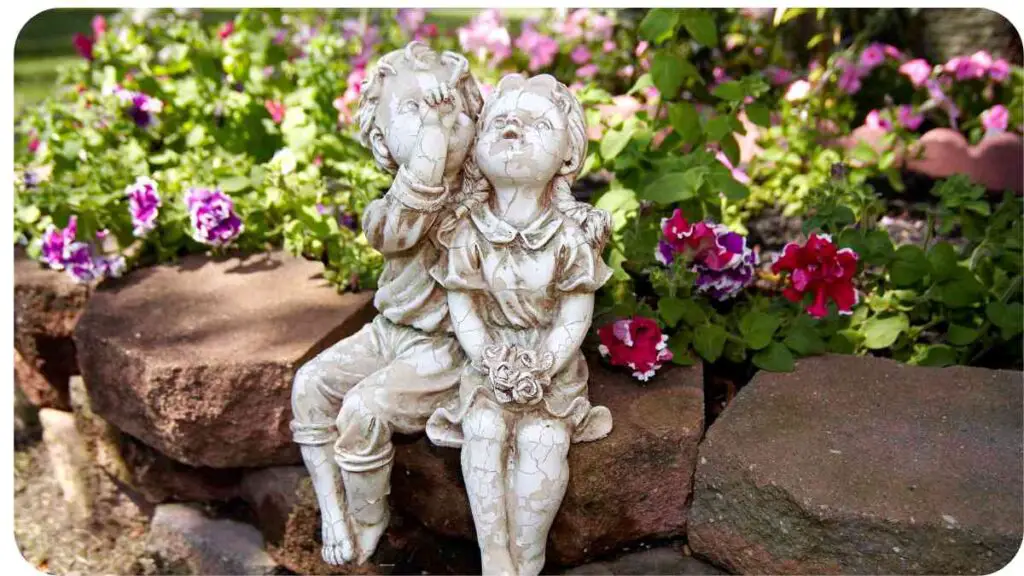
{"left": 462, "top": 397, "right": 517, "bottom": 576}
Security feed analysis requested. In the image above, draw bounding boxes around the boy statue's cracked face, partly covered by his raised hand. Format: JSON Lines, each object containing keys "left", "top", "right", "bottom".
{"left": 374, "top": 63, "right": 476, "bottom": 176}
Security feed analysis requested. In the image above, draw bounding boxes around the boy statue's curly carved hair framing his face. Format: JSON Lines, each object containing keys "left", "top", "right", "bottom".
{"left": 356, "top": 40, "right": 483, "bottom": 173}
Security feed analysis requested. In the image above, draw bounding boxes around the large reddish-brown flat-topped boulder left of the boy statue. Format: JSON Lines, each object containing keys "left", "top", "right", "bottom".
{"left": 75, "top": 251, "right": 375, "bottom": 468}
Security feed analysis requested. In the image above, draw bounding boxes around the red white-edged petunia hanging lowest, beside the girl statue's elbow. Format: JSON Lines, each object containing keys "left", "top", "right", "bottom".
{"left": 597, "top": 316, "right": 672, "bottom": 382}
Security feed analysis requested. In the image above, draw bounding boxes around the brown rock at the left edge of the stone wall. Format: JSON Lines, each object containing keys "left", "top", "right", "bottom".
{"left": 14, "top": 249, "right": 91, "bottom": 410}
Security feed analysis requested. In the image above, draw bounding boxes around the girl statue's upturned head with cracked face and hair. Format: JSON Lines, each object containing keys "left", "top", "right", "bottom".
{"left": 473, "top": 74, "right": 587, "bottom": 190}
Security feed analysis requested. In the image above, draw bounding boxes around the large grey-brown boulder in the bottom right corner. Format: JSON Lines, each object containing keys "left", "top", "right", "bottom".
{"left": 688, "top": 356, "right": 1024, "bottom": 574}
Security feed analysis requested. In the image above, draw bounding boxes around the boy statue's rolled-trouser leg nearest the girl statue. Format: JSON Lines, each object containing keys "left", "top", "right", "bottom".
{"left": 334, "top": 320, "right": 465, "bottom": 563}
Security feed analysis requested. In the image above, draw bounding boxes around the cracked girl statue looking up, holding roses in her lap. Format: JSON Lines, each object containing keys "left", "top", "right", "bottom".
{"left": 427, "top": 75, "right": 611, "bottom": 575}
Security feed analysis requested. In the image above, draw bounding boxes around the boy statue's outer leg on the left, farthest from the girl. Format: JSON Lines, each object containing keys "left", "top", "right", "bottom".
{"left": 291, "top": 324, "right": 386, "bottom": 565}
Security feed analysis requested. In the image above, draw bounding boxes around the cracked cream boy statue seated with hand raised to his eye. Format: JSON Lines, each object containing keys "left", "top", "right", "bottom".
{"left": 291, "top": 42, "right": 482, "bottom": 565}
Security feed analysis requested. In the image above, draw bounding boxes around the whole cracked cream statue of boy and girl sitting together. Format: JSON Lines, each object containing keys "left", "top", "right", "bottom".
{"left": 292, "top": 42, "right": 611, "bottom": 575}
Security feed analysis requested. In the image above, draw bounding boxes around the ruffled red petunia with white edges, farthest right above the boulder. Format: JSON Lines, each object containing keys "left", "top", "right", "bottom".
{"left": 771, "top": 234, "right": 859, "bottom": 318}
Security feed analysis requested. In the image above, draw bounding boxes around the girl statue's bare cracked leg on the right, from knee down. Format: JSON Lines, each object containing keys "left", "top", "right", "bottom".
{"left": 509, "top": 413, "right": 571, "bottom": 576}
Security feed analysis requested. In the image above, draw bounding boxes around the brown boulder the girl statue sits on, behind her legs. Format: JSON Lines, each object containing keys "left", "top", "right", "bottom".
{"left": 391, "top": 356, "right": 705, "bottom": 566}
